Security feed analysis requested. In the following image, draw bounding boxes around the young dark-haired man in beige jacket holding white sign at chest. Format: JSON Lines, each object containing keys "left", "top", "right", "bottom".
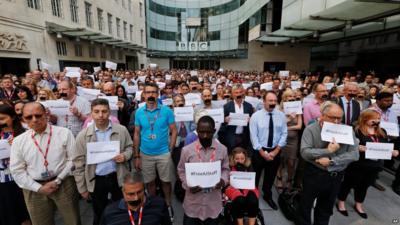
{"left": 73, "top": 98, "right": 133, "bottom": 225}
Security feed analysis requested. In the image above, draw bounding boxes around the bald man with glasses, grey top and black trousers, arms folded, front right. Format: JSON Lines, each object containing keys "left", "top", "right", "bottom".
{"left": 300, "top": 102, "right": 359, "bottom": 225}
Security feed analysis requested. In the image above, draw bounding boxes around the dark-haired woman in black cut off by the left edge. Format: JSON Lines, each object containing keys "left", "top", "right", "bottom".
{"left": 0, "top": 105, "right": 30, "bottom": 225}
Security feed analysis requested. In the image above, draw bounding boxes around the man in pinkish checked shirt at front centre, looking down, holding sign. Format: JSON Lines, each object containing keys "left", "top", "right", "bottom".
{"left": 178, "top": 116, "right": 229, "bottom": 225}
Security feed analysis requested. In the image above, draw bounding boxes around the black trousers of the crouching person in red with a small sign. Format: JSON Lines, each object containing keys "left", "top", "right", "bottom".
{"left": 231, "top": 191, "right": 258, "bottom": 219}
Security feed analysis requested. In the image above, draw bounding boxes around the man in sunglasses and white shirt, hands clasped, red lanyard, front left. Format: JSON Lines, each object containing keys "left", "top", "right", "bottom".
{"left": 10, "top": 102, "right": 81, "bottom": 225}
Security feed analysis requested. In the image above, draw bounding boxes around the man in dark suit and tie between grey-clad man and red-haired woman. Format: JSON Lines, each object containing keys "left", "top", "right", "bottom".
{"left": 338, "top": 82, "right": 360, "bottom": 126}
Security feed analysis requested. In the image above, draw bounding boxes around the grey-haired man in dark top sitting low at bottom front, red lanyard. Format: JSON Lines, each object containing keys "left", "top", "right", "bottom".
{"left": 100, "top": 173, "right": 171, "bottom": 225}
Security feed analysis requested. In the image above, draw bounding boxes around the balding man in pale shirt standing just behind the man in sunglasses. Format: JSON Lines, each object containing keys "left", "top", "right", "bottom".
{"left": 53, "top": 81, "right": 90, "bottom": 136}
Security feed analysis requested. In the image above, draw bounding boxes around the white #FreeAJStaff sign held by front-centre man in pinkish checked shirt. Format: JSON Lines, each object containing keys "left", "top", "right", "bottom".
{"left": 185, "top": 160, "right": 221, "bottom": 188}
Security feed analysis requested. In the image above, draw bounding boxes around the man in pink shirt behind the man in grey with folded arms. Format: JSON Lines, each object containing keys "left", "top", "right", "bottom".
{"left": 303, "top": 83, "right": 328, "bottom": 126}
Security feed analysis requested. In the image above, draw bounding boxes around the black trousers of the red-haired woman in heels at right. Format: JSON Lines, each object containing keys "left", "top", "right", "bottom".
{"left": 338, "top": 165, "right": 380, "bottom": 203}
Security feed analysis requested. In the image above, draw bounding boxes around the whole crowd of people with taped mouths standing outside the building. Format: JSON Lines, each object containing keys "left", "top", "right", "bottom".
{"left": 0, "top": 68, "right": 400, "bottom": 225}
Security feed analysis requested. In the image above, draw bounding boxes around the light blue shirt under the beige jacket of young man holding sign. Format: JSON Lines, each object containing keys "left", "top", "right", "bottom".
{"left": 94, "top": 121, "right": 117, "bottom": 176}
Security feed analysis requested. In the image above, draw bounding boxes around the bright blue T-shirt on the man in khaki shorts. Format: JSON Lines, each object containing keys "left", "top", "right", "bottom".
{"left": 135, "top": 104, "right": 175, "bottom": 155}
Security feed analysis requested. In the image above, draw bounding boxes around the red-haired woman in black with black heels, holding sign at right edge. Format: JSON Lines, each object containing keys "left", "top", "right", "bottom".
{"left": 336, "top": 109, "right": 399, "bottom": 219}
